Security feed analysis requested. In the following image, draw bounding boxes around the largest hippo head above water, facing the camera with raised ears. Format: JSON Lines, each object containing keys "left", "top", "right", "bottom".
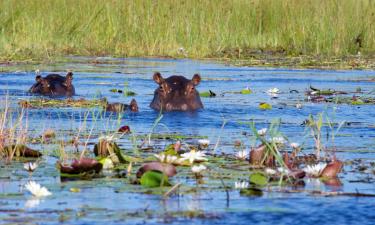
{"left": 150, "top": 72, "right": 203, "bottom": 111}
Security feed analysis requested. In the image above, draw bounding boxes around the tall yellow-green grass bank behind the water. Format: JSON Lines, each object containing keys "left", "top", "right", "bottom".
{"left": 0, "top": 0, "right": 375, "bottom": 60}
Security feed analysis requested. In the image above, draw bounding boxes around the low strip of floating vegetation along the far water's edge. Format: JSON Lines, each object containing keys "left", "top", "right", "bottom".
{"left": 0, "top": 53, "right": 375, "bottom": 72}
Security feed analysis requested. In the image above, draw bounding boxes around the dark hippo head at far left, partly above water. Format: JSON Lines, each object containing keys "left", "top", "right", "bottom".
{"left": 29, "top": 72, "right": 75, "bottom": 97}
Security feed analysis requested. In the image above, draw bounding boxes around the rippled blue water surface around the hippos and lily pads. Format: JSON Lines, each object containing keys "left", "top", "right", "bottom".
{"left": 0, "top": 58, "right": 375, "bottom": 224}
